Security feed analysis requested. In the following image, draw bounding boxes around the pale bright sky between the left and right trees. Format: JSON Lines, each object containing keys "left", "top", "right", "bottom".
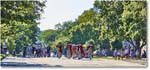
{"left": 38, "top": 0, "right": 94, "bottom": 31}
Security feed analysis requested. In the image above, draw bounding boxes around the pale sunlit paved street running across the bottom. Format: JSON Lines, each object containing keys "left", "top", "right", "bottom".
{"left": 1, "top": 57, "right": 146, "bottom": 67}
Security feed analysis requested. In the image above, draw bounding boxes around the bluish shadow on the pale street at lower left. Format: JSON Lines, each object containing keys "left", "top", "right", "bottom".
{"left": 0, "top": 62, "right": 62, "bottom": 67}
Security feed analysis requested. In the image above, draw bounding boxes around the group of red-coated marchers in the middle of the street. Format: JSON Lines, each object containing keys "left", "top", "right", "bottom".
{"left": 56, "top": 43, "right": 94, "bottom": 59}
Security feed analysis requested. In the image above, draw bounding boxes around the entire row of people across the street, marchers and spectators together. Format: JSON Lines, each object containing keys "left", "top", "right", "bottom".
{"left": 1, "top": 42, "right": 146, "bottom": 59}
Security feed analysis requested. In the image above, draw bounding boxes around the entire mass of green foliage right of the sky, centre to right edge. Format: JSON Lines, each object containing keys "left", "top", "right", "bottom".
{"left": 39, "top": 0, "right": 146, "bottom": 50}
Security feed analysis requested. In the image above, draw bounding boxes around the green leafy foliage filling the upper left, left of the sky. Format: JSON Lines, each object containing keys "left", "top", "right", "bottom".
{"left": 0, "top": 1, "right": 45, "bottom": 51}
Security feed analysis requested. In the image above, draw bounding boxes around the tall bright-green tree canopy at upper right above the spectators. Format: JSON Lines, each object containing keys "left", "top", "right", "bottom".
{"left": 94, "top": 0, "right": 146, "bottom": 50}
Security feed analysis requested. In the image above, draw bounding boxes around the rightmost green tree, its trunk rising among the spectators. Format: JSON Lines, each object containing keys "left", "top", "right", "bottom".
{"left": 122, "top": 1, "right": 147, "bottom": 56}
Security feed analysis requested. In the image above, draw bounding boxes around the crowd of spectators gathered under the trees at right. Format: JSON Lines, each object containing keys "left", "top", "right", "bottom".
{"left": 95, "top": 46, "right": 147, "bottom": 59}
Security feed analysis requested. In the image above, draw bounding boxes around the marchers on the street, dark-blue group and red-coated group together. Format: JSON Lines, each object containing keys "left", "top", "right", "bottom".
{"left": 19, "top": 42, "right": 94, "bottom": 59}
